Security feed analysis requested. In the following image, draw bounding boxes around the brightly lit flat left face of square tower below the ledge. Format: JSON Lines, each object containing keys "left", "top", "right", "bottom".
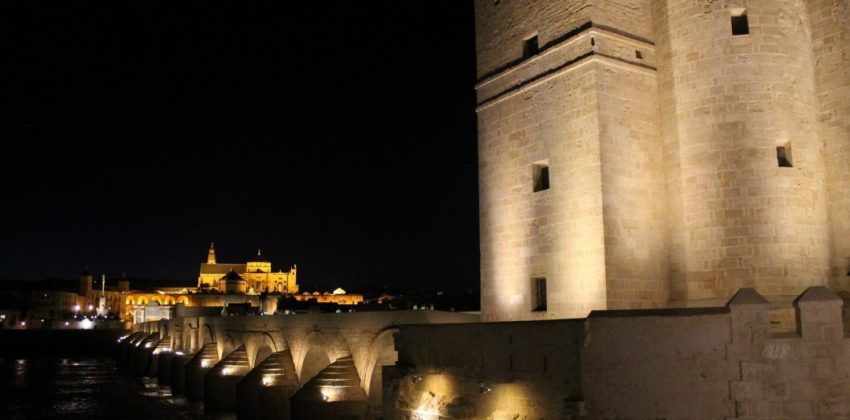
{"left": 478, "top": 60, "right": 606, "bottom": 320}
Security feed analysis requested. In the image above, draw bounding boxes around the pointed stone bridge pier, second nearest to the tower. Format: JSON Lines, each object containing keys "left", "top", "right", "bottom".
{"left": 236, "top": 350, "right": 301, "bottom": 420}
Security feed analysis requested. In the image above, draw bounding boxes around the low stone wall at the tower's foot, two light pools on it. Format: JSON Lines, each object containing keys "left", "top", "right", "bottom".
{"left": 383, "top": 287, "right": 850, "bottom": 419}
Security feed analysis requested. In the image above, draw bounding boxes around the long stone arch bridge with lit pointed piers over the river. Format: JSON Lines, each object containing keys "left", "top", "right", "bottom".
{"left": 119, "top": 311, "right": 478, "bottom": 419}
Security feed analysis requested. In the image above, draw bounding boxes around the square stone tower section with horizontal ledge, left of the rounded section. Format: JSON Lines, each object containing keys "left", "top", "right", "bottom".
{"left": 476, "top": 1, "right": 669, "bottom": 320}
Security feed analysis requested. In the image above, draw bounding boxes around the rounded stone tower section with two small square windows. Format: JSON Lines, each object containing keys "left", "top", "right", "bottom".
{"left": 654, "top": 0, "right": 829, "bottom": 305}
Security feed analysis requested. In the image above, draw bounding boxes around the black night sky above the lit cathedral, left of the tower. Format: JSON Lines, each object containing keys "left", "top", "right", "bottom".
{"left": 0, "top": 1, "right": 479, "bottom": 290}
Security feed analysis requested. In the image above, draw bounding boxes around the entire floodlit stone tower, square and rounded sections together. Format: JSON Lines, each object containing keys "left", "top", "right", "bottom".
{"left": 475, "top": 0, "right": 850, "bottom": 320}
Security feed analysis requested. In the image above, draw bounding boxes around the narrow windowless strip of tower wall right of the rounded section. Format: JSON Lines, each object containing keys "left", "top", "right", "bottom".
{"left": 808, "top": 0, "right": 850, "bottom": 290}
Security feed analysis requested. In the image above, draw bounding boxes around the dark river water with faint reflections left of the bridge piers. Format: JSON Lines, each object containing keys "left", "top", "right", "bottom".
{"left": 0, "top": 357, "right": 229, "bottom": 419}
